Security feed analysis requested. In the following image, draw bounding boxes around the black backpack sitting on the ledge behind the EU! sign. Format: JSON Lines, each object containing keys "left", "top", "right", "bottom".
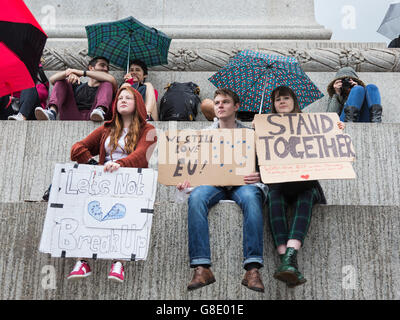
{"left": 160, "top": 82, "right": 200, "bottom": 121}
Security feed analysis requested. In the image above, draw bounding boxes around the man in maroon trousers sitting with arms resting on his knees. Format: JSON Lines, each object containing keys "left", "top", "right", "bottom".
{"left": 35, "top": 57, "right": 118, "bottom": 122}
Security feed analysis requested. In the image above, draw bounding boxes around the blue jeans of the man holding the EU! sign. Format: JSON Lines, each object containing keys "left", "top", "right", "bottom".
{"left": 188, "top": 185, "right": 264, "bottom": 266}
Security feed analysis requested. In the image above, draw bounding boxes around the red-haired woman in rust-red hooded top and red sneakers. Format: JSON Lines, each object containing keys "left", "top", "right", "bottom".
{"left": 68, "top": 87, "right": 157, "bottom": 282}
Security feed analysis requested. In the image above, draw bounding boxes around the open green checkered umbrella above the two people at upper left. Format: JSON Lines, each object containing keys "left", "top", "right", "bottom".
{"left": 85, "top": 17, "right": 171, "bottom": 68}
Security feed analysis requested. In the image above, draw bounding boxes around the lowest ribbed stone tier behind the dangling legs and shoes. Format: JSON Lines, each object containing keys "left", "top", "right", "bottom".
{"left": 0, "top": 203, "right": 400, "bottom": 300}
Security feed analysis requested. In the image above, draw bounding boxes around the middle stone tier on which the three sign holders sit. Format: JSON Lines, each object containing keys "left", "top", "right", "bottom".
{"left": 0, "top": 121, "right": 400, "bottom": 205}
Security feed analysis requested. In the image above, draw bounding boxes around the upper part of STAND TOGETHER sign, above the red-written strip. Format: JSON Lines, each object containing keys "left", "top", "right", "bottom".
{"left": 254, "top": 113, "right": 355, "bottom": 165}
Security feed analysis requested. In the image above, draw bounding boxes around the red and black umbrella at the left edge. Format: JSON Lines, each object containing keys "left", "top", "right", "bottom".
{"left": 0, "top": 0, "right": 47, "bottom": 96}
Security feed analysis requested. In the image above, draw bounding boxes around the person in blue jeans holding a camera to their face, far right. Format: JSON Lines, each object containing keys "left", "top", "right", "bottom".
{"left": 326, "top": 67, "right": 382, "bottom": 122}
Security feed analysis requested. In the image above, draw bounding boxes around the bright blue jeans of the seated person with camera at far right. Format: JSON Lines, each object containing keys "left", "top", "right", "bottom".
{"left": 340, "top": 84, "right": 381, "bottom": 122}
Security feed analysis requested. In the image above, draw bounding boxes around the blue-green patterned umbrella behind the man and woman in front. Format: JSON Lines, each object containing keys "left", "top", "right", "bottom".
{"left": 208, "top": 50, "right": 324, "bottom": 113}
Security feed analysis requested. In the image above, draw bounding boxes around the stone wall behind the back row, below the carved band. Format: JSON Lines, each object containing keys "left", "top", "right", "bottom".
{"left": 46, "top": 71, "right": 400, "bottom": 123}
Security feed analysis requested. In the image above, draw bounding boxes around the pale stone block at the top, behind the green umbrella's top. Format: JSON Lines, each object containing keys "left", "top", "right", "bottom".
{"left": 26, "top": 0, "right": 332, "bottom": 39}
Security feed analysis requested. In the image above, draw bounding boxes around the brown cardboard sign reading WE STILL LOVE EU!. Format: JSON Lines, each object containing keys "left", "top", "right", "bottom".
{"left": 158, "top": 129, "right": 255, "bottom": 186}
